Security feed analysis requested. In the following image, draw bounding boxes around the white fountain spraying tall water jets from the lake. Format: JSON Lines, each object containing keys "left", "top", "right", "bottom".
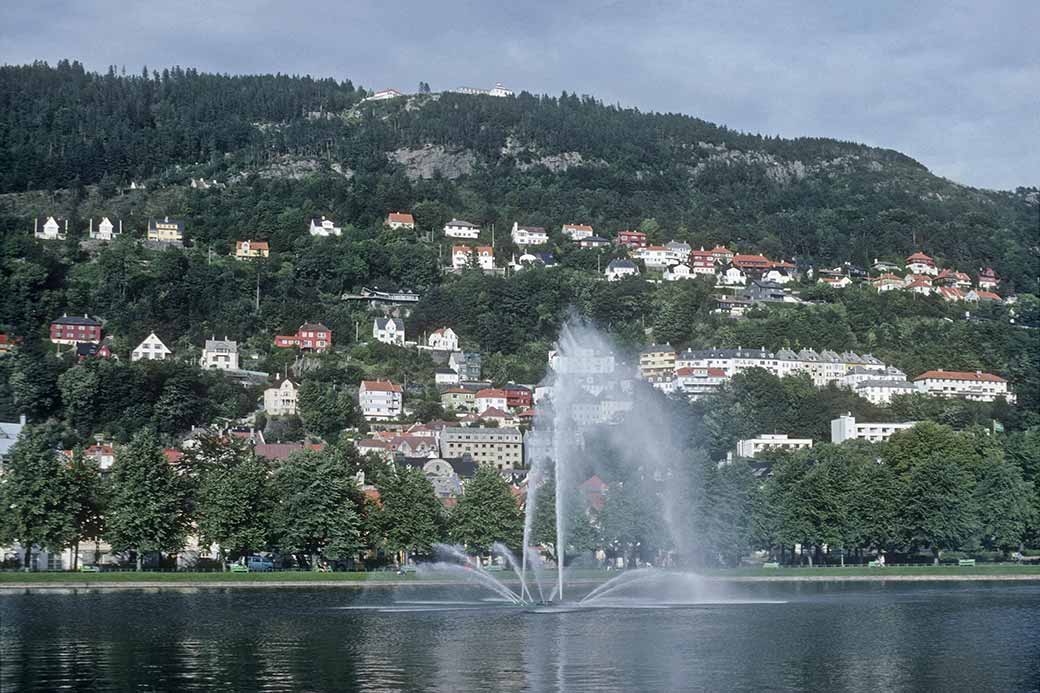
{"left": 418, "top": 317, "right": 700, "bottom": 606}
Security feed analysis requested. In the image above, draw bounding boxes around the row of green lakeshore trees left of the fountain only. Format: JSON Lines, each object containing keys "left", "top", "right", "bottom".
{"left": 0, "top": 427, "right": 523, "bottom": 570}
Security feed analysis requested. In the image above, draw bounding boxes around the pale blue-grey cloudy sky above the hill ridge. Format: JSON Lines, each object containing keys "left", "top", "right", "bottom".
{"left": 0, "top": 0, "right": 1040, "bottom": 189}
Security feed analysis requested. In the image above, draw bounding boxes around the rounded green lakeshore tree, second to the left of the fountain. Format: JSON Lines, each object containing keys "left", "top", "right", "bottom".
{"left": 376, "top": 466, "right": 444, "bottom": 561}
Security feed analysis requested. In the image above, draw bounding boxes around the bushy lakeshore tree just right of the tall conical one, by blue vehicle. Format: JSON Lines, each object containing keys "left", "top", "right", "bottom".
{"left": 186, "top": 441, "right": 275, "bottom": 569}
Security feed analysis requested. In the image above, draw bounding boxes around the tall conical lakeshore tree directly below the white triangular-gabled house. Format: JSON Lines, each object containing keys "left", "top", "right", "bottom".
{"left": 105, "top": 429, "right": 188, "bottom": 570}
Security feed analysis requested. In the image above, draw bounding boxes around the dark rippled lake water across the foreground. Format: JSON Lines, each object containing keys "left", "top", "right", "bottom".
{"left": 0, "top": 583, "right": 1040, "bottom": 693}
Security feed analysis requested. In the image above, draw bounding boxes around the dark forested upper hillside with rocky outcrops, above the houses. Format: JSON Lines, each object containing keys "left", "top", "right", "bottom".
{"left": 0, "top": 61, "right": 1040, "bottom": 290}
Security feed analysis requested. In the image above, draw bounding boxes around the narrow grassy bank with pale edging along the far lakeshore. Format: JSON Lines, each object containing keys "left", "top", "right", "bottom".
{"left": 0, "top": 572, "right": 1040, "bottom": 595}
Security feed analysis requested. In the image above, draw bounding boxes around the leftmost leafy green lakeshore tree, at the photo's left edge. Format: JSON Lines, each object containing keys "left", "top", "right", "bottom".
{"left": 0, "top": 427, "right": 75, "bottom": 570}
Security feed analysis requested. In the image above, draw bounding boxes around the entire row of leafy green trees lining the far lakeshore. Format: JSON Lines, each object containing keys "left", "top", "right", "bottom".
{"left": 2, "top": 412, "right": 1040, "bottom": 568}
